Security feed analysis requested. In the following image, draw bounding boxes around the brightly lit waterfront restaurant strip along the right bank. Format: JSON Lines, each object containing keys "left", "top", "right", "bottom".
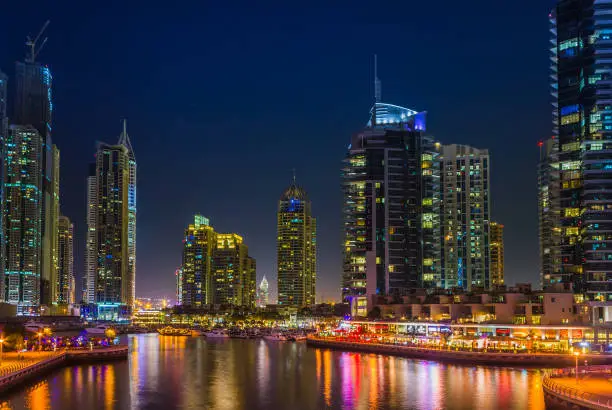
{"left": 327, "top": 320, "right": 612, "bottom": 353}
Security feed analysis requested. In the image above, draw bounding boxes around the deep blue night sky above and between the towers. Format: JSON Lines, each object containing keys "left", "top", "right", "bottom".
{"left": 0, "top": 0, "right": 554, "bottom": 299}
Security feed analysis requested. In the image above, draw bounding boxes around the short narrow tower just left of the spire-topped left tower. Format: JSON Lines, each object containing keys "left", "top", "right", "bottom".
{"left": 55, "top": 215, "right": 75, "bottom": 304}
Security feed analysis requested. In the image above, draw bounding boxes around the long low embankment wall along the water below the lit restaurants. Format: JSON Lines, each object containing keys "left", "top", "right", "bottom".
{"left": 307, "top": 336, "right": 612, "bottom": 366}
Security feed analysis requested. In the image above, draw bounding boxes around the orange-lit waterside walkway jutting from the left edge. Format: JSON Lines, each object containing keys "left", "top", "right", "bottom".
{"left": 0, "top": 346, "right": 128, "bottom": 394}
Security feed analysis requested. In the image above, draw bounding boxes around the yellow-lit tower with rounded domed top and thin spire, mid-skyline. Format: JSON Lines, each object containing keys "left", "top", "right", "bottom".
{"left": 276, "top": 176, "right": 317, "bottom": 306}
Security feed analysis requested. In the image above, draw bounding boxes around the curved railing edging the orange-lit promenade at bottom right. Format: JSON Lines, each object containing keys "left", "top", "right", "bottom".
{"left": 542, "top": 366, "right": 612, "bottom": 409}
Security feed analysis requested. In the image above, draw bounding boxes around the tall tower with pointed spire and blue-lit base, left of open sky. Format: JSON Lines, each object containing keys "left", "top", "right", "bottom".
{"left": 86, "top": 123, "right": 136, "bottom": 320}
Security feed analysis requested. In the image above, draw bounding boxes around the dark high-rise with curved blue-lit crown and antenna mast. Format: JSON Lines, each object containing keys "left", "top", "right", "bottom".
{"left": 342, "top": 91, "right": 441, "bottom": 316}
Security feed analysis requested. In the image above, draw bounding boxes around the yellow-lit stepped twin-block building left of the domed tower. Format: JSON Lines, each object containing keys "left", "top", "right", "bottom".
{"left": 177, "top": 215, "right": 256, "bottom": 308}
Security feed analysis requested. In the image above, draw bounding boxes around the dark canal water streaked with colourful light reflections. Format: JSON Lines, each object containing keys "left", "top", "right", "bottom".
{"left": 0, "top": 335, "right": 544, "bottom": 410}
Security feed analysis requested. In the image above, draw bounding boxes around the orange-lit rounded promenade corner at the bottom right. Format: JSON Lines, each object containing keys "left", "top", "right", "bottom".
{"left": 542, "top": 366, "right": 612, "bottom": 410}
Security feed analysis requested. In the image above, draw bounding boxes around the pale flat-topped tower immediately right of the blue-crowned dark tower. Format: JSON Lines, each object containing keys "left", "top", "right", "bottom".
{"left": 440, "top": 144, "right": 491, "bottom": 290}
